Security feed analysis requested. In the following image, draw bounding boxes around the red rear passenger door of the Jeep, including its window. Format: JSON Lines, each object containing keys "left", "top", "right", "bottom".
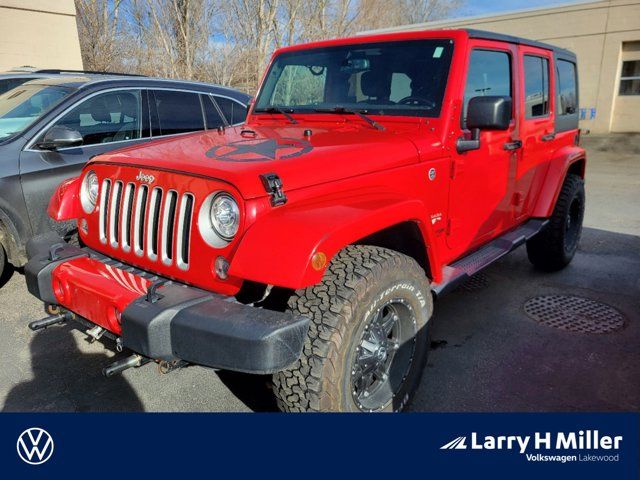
{"left": 513, "top": 45, "right": 555, "bottom": 221}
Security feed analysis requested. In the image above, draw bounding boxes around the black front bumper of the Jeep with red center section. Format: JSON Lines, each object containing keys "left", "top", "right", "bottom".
{"left": 25, "top": 235, "right": 309, "bottom": 374}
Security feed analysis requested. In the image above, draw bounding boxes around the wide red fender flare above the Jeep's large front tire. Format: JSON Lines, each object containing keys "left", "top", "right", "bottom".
{"left": 229, "top": 195, "right": 435, "bottom": 290}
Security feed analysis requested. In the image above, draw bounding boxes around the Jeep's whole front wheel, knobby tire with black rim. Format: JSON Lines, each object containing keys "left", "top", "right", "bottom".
{"left": 273, "top": 246, "right": 433, "bottom": 412}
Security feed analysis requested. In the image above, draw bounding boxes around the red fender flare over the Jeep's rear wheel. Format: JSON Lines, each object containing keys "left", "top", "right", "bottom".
{"left": 531, "top": 145, "right": 586, "bottom": 218}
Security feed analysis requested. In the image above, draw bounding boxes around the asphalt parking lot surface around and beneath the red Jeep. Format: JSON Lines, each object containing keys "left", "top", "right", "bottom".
{"left": 0, "top": 137, "right": 640, "bottom": 412}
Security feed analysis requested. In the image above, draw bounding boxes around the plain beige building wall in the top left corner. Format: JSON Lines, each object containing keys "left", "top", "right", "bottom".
{"left": 0, "top": 0, "right": 82, "bottom": 72}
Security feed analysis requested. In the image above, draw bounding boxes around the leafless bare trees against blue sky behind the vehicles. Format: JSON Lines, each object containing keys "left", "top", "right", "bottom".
{"left": 75, "top": 0, "right": 461, "bottom": 92}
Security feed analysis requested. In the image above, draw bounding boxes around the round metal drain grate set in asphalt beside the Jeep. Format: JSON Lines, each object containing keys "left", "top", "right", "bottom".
{"left": 524, "top": 295, "right": 624, "bottom": 333}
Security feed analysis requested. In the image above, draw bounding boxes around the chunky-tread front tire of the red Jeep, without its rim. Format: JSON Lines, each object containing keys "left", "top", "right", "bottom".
{"left": 273, "top": 246, "right": 433, "bottom": 412}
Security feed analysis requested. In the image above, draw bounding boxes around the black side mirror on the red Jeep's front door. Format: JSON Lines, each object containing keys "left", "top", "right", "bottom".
{"left": 456, "top": 96, "right": 512, "bottom": 153}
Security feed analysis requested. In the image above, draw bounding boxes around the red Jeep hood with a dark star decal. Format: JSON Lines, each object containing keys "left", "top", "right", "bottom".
{"left": 93, "top": 123, "right": 436, "bottom": 199}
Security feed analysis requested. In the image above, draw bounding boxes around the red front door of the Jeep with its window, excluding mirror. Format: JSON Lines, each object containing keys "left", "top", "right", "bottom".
{"left": 447, "top": 40, "right": 517, "bottom": 258}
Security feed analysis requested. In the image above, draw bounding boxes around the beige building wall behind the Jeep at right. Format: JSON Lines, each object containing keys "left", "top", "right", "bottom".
{"left": 362, "top": 0, "right": 640, "bottom": 133}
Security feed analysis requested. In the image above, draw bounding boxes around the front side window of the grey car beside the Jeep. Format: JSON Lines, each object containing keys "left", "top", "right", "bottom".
{"left": 55, "top": 90, "right": 142, "bottom": 146}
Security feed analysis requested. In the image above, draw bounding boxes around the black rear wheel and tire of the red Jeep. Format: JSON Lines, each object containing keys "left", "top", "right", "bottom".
{"left": 527, "top": 174, "right": 585, "bottom": 272}
